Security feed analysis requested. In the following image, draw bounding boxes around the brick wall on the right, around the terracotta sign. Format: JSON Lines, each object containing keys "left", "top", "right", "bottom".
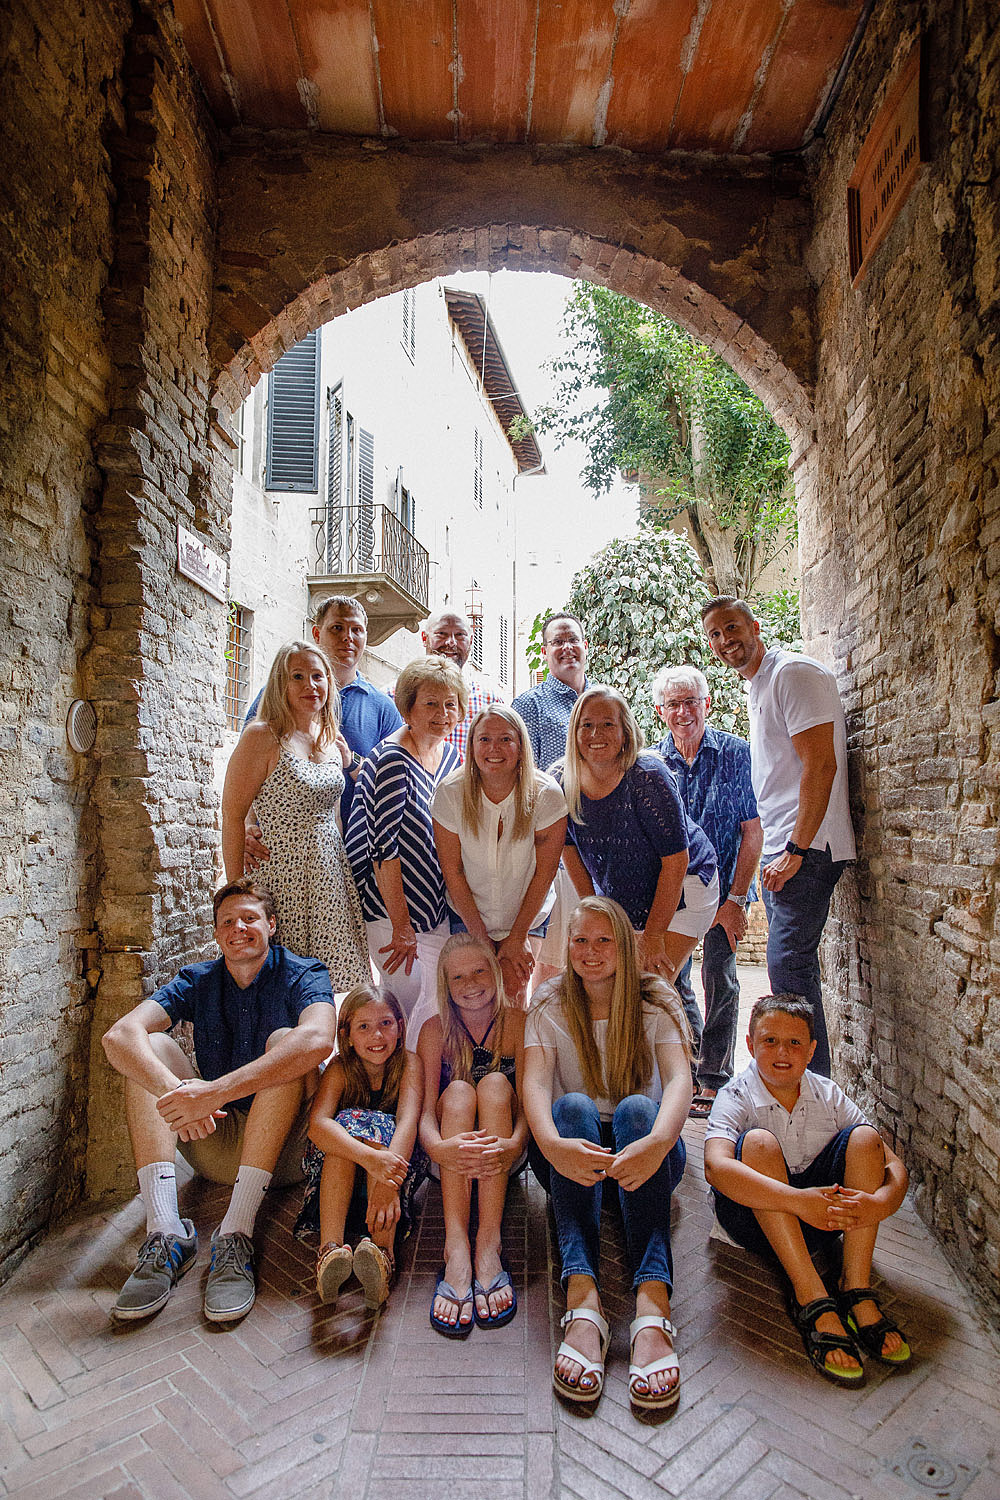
{"left": 802, "top": 0, "right": 1000, "bottom": 1311}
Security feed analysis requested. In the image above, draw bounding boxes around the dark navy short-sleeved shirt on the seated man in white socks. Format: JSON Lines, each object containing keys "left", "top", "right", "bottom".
{"left": 150, "top": 942, "right": 333, "bottom": 1110}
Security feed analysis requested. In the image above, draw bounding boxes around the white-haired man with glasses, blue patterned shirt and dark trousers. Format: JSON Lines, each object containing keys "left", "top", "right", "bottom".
{"left": 652, "top": 666, "right": 763, "bottom": 1119}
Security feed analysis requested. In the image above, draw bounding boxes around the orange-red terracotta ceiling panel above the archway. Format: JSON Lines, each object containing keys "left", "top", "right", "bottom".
{"left": 175, "top": 0, "right": 867, "bottom": 155}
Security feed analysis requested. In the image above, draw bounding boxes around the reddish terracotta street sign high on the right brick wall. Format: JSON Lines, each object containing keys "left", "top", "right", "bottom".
{"left": 847, "top": 42, "right": 924, "bottom": 287}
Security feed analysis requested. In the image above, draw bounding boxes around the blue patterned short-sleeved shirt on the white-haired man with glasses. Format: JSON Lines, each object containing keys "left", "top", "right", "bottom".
{"left": 655, "top": 725, "right": 757, "bottom": 902}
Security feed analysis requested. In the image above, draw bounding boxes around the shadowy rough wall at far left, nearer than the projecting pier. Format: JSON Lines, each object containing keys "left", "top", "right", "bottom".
{"left": 0, "top": 0, "right": 127, "bottom": 1277}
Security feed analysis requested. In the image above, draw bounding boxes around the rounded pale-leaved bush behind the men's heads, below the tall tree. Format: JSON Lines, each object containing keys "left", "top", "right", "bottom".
{"left": 565, "top": 527, "right": 798, "bottom": 744}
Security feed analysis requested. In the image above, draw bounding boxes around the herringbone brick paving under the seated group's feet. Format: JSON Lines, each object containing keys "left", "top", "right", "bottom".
{"left": 0, "top": 971, "right": 1000, "bottom": 1500}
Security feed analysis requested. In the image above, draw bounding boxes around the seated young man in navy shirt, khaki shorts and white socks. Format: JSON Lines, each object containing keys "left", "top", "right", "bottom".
{"left": 103, "top": 879, "right": 337, "bottom": 1323}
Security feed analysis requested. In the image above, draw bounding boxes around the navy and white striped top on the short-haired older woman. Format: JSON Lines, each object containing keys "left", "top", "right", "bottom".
{"left": 345, "top": 740, "right": 459, "bottom": 933}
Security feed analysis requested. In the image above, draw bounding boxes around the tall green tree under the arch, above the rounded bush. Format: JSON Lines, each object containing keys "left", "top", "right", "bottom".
{"left": 535, "top": 282, "right": 795, "bottom": 597}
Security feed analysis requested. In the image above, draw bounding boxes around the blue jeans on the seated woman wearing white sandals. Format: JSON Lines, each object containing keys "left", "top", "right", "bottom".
{"left": 531, "top": 1094, "right": 687, "bottom": 1290}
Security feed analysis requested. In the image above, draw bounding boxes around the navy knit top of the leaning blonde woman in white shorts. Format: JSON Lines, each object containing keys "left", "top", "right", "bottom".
{"left": 556, "top": 752, "right": 715, "bottom": 929}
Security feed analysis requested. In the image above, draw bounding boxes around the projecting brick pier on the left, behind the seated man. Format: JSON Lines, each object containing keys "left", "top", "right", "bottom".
{"left": 85, "top": 5, "right": 234, "bottom": 1196}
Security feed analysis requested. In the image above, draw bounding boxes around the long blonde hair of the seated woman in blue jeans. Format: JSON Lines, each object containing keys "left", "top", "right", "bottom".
{"left": 543, "top": 896, "right": 691, "bottom": 1103}
